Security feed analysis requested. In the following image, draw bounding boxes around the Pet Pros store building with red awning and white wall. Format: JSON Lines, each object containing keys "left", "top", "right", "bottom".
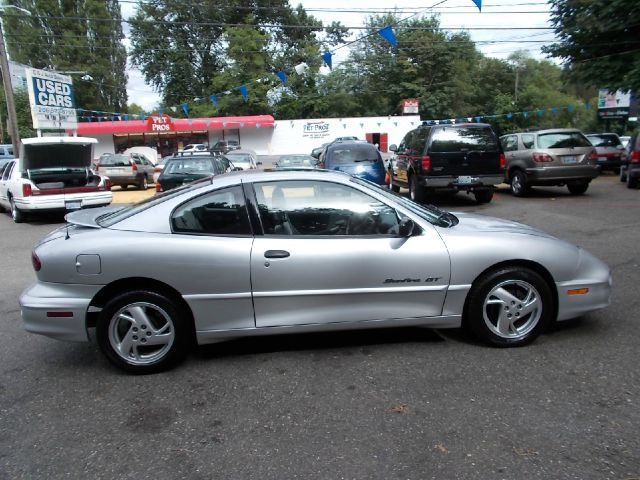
{"left": 68, "top": 114, "right": 421, "bottom": 156}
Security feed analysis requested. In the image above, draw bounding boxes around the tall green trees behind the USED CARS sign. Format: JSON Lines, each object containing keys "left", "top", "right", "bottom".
{"left": 3, "top": 0, "right": 127, "bottom": 112}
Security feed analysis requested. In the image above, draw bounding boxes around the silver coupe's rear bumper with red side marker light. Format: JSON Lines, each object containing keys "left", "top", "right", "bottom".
{"left": 19, "top": 282, "right": 101, "bottom": 342}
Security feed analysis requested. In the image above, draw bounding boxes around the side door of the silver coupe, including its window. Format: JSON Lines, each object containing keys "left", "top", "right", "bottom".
{"left": 251, "top": 180, "right": 450, "bottom": 327}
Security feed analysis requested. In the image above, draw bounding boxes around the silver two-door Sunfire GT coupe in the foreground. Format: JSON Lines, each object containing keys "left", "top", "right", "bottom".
{"left": 20, "top": 170, "right": 611, "bottom": 373}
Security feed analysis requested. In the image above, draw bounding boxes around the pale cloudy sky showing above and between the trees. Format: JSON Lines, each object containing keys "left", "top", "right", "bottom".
{"left": 121, "top": 0, "right": 554, "bottom": 110}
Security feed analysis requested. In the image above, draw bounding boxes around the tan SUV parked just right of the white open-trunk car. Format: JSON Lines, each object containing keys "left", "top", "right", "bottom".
{"left": 95, "top": 153, "right": 154, "bottom": 190}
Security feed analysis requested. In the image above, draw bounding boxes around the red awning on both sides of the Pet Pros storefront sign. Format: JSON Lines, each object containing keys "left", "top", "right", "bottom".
{"left": 77, "top": 115, "right": 275, "bottom": 137}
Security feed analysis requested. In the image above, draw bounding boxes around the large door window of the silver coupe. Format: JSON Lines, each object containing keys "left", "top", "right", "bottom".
{"left": 255, "top": 180, "right": 399, "bottom": 236}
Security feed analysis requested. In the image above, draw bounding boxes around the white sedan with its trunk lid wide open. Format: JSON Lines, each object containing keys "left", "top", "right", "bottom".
{"left": 0, "top": 137, "right": 113, "bottom": 223}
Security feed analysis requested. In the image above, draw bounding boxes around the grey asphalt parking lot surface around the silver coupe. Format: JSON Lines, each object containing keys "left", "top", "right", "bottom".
{"left": 0, "top": 174, "right": 640, "bottom": 480}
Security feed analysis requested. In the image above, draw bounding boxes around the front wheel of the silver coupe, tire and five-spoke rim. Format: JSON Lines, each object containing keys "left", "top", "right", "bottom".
{"left": 464, "top": 266, "right": 555, "bottom": 347}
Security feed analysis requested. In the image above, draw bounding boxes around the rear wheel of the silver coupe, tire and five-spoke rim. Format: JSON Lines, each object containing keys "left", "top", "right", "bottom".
{"left": 96, "top": 290, "right": 193, "bottom": 374}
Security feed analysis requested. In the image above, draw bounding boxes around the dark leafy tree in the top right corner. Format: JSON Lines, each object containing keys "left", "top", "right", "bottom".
{"left": 543, "top": 0, "right": 640, "bottom": 92}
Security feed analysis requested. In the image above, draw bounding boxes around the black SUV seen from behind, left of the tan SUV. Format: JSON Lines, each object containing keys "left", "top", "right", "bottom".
{"left": 389, "top": 123, "right": 505, "bottom": 203}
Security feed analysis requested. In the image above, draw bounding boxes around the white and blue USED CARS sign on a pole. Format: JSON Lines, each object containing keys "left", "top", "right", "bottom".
{"left": 25, "top": 68, "right": 78, "bottom": 130}
